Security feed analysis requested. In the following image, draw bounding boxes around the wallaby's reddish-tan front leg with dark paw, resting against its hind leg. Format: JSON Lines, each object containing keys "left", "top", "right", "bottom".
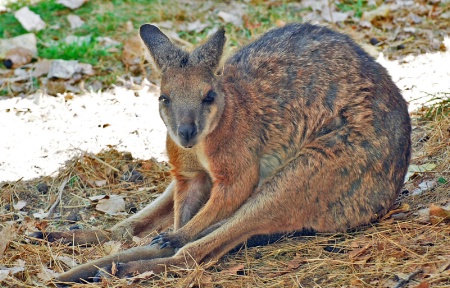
{"left": 152, "top": 165, "right": 259, "bottom": 248}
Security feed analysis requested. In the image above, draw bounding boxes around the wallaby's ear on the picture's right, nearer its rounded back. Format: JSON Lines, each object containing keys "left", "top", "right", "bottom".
{"left": 189, "top": 27, "right": 227, "bottom": 71}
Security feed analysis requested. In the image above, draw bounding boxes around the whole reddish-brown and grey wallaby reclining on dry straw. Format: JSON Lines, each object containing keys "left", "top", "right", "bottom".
{"left": 37, "top": 24, "right": 411, "bottom": 281}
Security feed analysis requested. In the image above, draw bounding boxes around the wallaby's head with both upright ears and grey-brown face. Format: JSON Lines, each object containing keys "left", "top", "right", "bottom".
{"left": 139, "top": 24, "right": 226, "bottom": 148}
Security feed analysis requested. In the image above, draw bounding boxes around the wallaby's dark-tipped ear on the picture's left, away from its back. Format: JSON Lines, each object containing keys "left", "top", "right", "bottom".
{"left": 139, "top": 24, "right": 189, "bottom": 71}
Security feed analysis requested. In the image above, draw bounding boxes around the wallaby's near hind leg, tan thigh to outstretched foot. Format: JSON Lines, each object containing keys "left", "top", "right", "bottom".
{"left": 99, "top": 145, "right": 395, "bottom": 277}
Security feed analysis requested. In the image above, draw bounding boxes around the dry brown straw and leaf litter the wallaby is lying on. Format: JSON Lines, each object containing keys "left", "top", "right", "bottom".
{"left": 0, "top": 106, "right": 450, "bottom": 288}
